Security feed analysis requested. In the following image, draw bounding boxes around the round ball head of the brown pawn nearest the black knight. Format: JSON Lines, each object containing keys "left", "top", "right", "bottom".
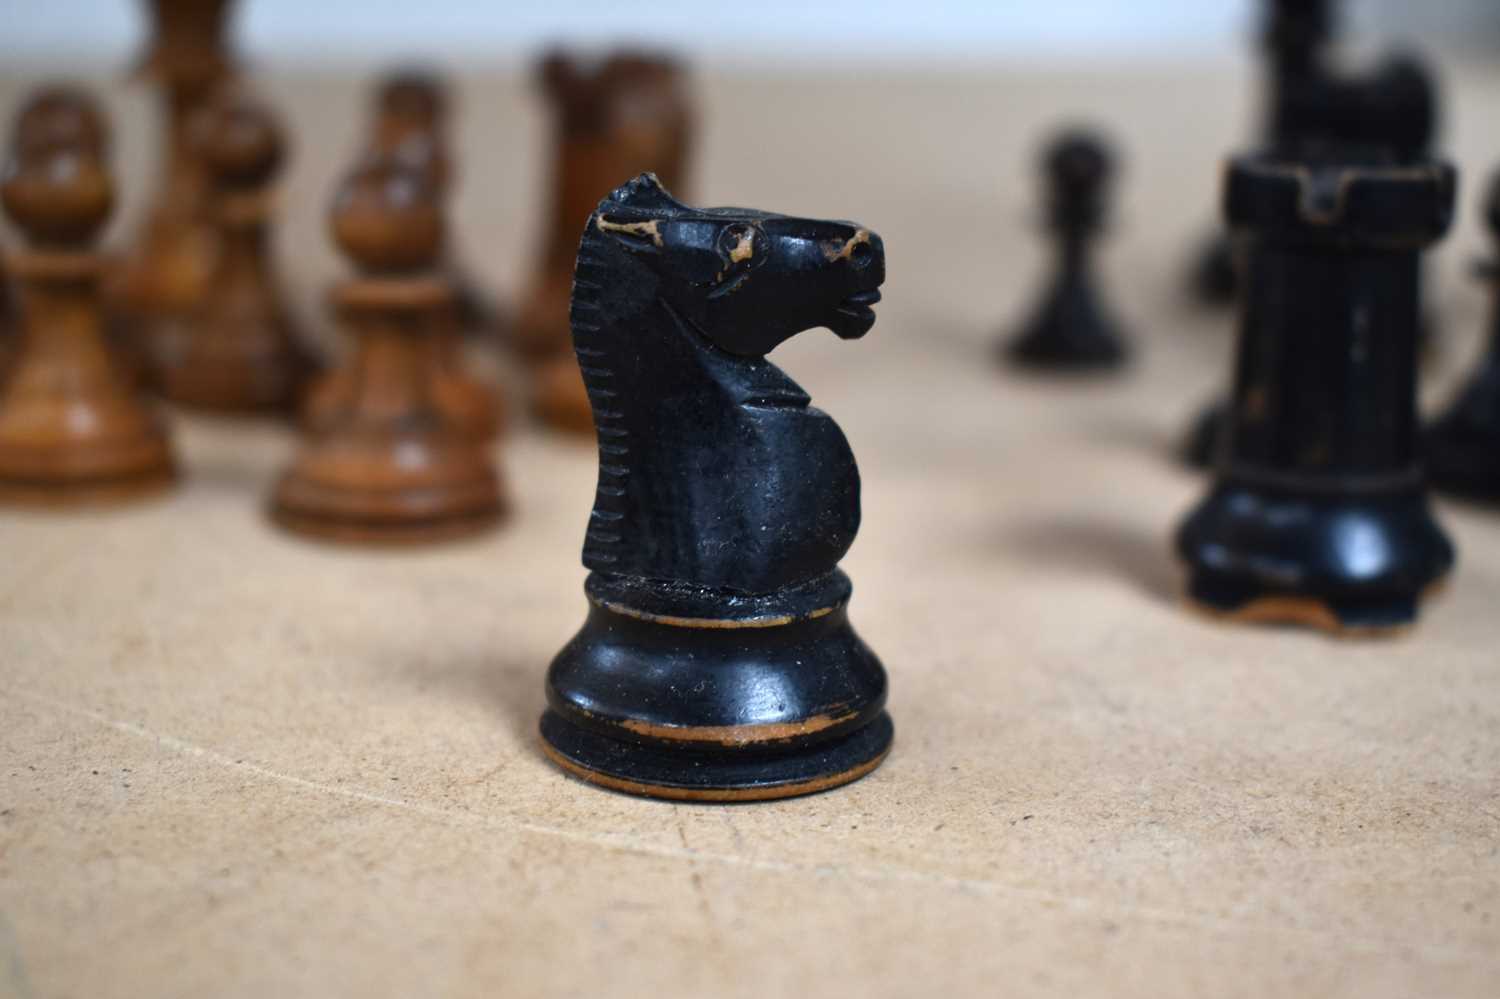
{"left": 329, "top": 156, "right": 443, "bottom": 275}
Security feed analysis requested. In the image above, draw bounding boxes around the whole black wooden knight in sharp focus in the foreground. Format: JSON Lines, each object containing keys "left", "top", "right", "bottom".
{"left": 542, "top": 174, "right": 893, "bottom": 801}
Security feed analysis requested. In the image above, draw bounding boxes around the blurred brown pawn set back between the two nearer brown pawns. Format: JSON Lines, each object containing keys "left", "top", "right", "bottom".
{"left": 152, "top": 95, "right": 315, "bottom": 413}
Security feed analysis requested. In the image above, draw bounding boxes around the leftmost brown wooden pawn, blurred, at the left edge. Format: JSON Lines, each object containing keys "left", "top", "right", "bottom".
{"left": 0, "top": 90, "right": 173, "bottom": 503}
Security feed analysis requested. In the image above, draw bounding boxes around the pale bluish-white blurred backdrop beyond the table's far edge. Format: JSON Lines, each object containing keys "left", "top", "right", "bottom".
{"left": 0, "top": 0, "right": 1500, "bottom": 68}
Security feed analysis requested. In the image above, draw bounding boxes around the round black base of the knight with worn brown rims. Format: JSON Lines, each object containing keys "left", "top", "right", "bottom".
{"left": 540, "top": 572, "right": 894, "bottom": 801}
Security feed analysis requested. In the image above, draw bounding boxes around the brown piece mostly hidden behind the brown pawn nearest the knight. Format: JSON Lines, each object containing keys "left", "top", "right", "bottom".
{"left": 303, "top": 72, "right": 503, "bottom": 441}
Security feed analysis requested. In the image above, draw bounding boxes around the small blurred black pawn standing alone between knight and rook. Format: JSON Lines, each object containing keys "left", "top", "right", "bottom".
{"left": 1005, "top": 132, "right": 1127, "bottom": 371}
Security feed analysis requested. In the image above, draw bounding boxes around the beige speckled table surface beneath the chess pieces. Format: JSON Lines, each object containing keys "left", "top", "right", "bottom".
{"left": 0, "top": 62, "right": 1500, "bottom": 998}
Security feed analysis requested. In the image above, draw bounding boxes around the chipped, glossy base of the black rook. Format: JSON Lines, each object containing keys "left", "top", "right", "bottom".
{"left": 1178, "top": 483, "right": 1454, "bottom": 635}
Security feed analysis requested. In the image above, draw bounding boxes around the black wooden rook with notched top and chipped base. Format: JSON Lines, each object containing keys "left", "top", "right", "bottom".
{"left": 1178, "top": 151, "right": 1455, "bottom": 633}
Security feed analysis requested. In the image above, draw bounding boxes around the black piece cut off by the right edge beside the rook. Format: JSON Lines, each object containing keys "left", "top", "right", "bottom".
{"left": 1427, "top": 174, "right": 1500, "bottom": 503}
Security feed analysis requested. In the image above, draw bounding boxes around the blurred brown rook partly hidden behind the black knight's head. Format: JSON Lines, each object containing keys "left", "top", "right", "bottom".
{"left": 513, "top": 53, "right": 693, "bottom": 434}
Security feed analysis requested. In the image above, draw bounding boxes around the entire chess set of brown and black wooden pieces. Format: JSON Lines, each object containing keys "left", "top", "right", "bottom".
{"left": 0, "top": 0, "right": 1500, "bottom": 801}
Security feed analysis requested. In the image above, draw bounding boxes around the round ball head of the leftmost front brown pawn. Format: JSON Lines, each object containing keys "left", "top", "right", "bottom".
{"left": 0, "top": 147, "right": 114, "bottom": 249}
